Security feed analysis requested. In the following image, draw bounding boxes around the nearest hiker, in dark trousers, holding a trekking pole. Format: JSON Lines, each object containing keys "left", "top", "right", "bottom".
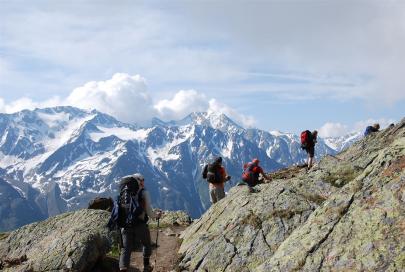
{"left": 119, "top": 173, "right": 162, "bottom": 272}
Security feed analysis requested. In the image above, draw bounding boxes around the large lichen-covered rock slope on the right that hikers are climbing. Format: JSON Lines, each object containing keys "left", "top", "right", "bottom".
{"left": 179, "top": 119, "right": 405, "bottom": 271}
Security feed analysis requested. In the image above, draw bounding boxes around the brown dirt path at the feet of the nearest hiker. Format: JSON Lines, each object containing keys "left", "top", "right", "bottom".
{"left": 128, "top": 226, "right": 185, "bottom": 272}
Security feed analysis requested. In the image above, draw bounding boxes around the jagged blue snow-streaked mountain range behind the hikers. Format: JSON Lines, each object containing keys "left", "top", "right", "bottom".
{"left": 0, "top": 107, "right": 348, "bottom": 230}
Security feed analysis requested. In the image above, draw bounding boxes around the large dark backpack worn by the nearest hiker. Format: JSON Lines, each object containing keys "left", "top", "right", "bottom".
{"left": 107, "top": 177, "right": 147, "bottom": 230}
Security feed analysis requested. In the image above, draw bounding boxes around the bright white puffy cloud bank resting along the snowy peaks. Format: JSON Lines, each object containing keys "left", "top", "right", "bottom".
{"left": 0, "top": 73, "right": 255, "bottom": 127}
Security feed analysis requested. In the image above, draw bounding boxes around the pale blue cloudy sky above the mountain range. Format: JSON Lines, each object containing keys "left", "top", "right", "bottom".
{"left": 0, "top": 0, "right": 405, "bottom": 137}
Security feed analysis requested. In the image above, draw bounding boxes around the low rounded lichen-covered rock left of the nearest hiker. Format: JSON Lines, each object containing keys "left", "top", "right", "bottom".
{"left": 0, "top": 209, "right": 110, "bottom": 271}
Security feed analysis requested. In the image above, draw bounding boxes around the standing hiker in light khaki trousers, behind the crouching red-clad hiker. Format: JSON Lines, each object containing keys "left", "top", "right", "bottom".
{"left": 202, "top": 157, "right": 231, "bottom": 204}
